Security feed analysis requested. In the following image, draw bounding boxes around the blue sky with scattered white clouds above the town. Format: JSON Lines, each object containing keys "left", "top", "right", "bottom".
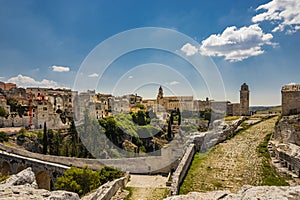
{"left": 0, "top": 0, "right": 300, "bottom": 105}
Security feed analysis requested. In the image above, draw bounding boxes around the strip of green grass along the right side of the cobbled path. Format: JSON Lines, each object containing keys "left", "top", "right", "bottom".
{"left": 256, "top": 133, "right": 289, "bottom": 186}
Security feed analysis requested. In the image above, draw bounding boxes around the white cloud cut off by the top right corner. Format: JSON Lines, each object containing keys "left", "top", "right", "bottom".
{"left": 252, "top": 0, "right": 300, "bottom": 33}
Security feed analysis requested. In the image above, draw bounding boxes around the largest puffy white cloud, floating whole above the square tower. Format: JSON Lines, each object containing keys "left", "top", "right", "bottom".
{"left": 200, "top": 24, "right": 275, "bottom": 62}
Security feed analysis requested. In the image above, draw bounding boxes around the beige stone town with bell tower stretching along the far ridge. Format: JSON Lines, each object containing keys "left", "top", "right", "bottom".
{"left": 0, "top": 82, "right": 250, "bottom": 129}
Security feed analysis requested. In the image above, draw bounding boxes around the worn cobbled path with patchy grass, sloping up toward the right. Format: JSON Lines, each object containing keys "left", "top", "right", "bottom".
{"left": 180, "top": 117, "right": 277, "bottom": 193}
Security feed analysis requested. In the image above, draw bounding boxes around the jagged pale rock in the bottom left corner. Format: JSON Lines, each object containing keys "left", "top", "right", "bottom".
{"left": 0, "top": 167, "right": 79, "bottom": 200}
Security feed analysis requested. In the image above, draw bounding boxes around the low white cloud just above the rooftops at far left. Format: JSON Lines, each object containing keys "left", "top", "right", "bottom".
{"left": 7, "top": 74, "right": 58, "bottom": 88}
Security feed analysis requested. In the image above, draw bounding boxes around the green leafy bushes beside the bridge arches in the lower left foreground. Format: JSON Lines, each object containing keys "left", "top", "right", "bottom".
{"left": 55, "top": 166, "right": 124, "bottom": 196}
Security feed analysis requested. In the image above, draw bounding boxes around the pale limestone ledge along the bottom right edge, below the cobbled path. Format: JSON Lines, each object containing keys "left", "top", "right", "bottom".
{"left": 165, "top": 186, "right": 300, "bottom": 200}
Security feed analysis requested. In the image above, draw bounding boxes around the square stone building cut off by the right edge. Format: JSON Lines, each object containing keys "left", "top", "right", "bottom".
{"left": 281, "top": 84, "right": 300, "bottom": 115}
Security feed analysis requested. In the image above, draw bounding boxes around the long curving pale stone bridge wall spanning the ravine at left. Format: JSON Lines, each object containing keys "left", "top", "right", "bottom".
{"left": 0, "top": 144, "right": 180, "bottom": 174}
